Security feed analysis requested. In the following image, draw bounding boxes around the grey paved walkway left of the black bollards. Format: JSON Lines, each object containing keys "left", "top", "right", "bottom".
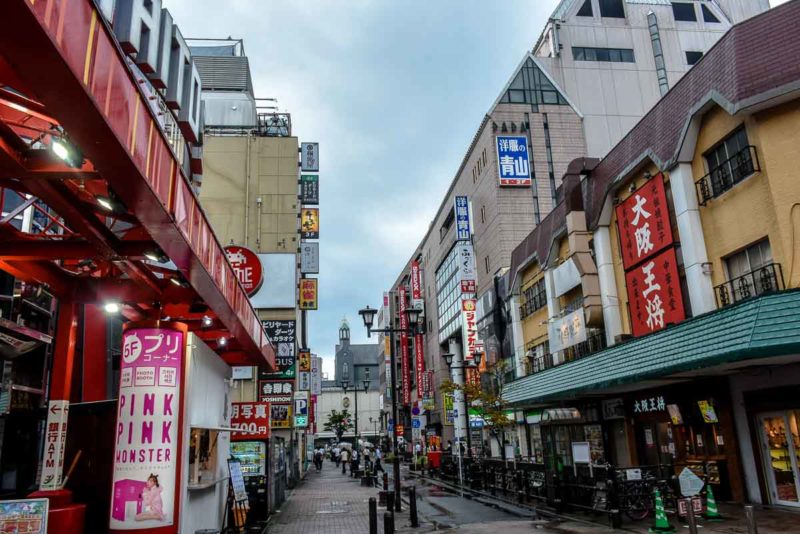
{"left": 267, "top": 461, "right": 408, "bottom": 534}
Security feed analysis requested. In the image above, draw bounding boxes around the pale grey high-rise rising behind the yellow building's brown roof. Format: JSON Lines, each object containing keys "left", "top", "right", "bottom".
{"left": 533, "top": 0, "right": 769, "bottom": 157}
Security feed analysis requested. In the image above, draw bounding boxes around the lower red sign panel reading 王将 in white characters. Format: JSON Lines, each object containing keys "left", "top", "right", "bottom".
{"left": 625, "top": 247, "right": 686, "bottom": 337}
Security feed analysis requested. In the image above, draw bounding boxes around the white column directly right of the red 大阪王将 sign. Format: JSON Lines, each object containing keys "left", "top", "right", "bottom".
{"left": 669, "top": 163, "right": 717, "bottom": 315}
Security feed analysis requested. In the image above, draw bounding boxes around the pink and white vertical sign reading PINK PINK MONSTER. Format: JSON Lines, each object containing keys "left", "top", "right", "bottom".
{"left": 109, "top": 325, "right": 186, "bottom": 530}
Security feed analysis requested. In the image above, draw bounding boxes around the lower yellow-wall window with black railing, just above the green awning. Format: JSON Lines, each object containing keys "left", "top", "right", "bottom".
{"left": 714, "top": 239, "right": 784, "bottom": 306}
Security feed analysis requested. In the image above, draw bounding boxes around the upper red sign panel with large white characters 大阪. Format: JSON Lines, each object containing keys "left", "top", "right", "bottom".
{"left": 616, "top": 173, "right": 672, "bottom": 269}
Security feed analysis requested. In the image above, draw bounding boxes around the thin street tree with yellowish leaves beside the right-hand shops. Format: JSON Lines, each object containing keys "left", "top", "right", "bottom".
{"left": 439, "top": 360, "right": 514, "bottom": 459}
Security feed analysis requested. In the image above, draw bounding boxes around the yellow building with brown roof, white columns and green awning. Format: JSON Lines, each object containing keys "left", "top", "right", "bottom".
{"left": 504, "top": 2, "right": 800, "bottom": 507}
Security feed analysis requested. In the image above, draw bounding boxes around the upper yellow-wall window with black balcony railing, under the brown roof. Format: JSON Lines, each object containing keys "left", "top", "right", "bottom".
{"left": 698, "top": 127, "right": 759, "bottom": 204}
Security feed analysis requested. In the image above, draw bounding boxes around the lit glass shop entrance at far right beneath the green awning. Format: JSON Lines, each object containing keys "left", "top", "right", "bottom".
{"left": 758, "top": 410, "right": 800, "bottom": 507}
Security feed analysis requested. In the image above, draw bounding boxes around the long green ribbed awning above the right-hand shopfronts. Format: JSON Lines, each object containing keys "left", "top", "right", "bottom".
{"left": 503, "top": 290, "right": 800, "bottom": 404}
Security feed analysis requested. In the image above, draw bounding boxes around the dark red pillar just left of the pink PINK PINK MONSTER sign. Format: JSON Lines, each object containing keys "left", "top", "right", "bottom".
{"left": 81, "top": 304, "right": 108, "bottom": 402}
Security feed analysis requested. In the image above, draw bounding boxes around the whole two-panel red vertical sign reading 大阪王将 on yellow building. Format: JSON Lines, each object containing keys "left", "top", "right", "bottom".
{"left": 616, "top": 173, "right": 686, "bottom": 337}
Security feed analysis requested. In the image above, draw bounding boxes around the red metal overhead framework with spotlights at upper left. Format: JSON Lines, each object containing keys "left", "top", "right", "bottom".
{"left": 0, "top": 0, "right": 275, "bottom": 368}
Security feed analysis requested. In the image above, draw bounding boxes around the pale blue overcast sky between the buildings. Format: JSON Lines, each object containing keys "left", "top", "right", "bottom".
{"left": 164, "top": 0, "right": 782, "bottom": 372}
